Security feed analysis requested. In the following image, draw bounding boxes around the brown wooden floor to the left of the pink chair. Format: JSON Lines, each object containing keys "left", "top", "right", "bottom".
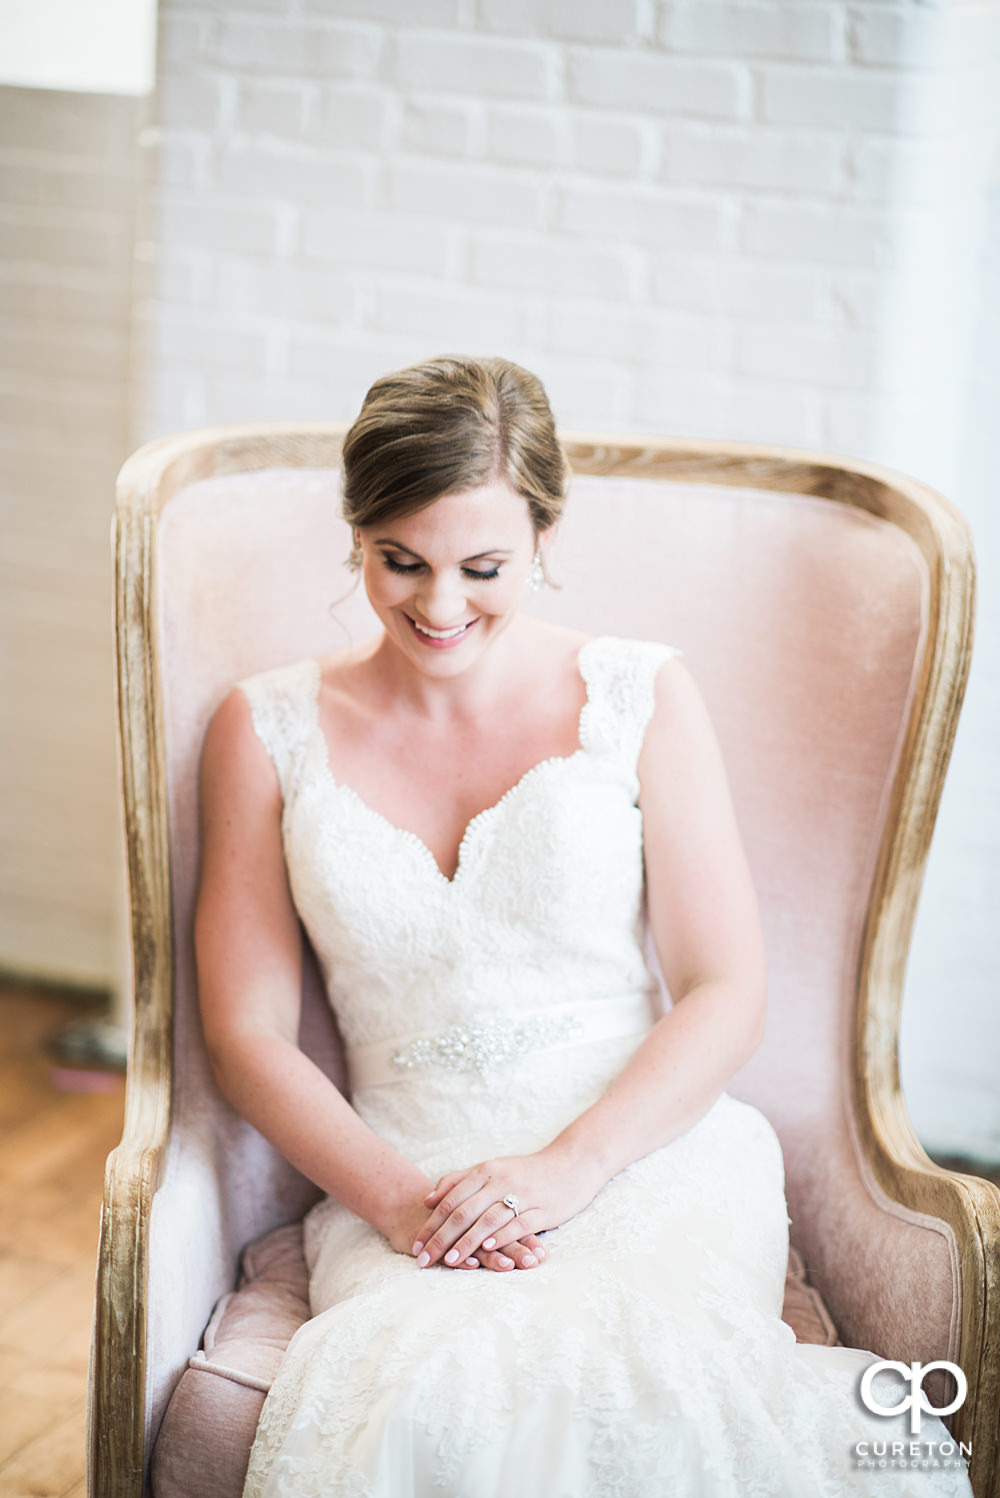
{"left": 0, "top": 983, "right": 124, "bottom": 1498}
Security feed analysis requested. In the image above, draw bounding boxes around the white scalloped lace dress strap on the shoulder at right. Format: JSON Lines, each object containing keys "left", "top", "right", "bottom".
{"left": 579, "top": 635, "right": 683, "bottom": 789}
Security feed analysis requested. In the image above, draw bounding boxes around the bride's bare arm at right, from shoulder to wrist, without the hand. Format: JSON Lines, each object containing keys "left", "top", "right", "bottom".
{"left": 541, "top": 661, "right": 766, "bottom": 1179}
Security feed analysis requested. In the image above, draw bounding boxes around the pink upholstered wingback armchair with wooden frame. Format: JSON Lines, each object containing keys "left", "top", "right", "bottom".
{"left": 88, "top": 424, "right": 1000, "bottom": 1498}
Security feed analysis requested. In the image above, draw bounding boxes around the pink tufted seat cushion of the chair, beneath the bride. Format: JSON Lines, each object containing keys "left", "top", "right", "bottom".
{"left": 151, "top": 1222, "right": 840, "bottom": 1498}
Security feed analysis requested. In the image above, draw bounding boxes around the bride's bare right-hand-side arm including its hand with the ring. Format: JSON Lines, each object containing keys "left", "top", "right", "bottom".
{"left": 421, "top": 661, "right": 766, "bottom": 1263}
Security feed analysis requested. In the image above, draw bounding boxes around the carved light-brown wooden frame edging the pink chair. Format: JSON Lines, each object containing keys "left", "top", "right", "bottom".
{"left": 87, "top": 422, "right": 1000, "bottom": 1498}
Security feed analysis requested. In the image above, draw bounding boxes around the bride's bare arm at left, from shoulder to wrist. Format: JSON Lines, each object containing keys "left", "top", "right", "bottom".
{"left": 195, "top": 689, "right": 427, "bottom": 1251}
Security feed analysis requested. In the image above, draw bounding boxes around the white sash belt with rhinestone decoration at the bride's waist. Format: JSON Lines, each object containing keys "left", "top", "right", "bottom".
{"left": 347, "top": 992, "right": 653, "bottom": 1088}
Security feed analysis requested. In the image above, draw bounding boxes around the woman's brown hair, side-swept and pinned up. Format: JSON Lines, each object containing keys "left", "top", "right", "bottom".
{"left": 343, "top": 355, "right": 569, "bottom": 532}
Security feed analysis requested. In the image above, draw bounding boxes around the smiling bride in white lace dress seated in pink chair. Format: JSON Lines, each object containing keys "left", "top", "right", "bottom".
{"left": 195, "top": 358, "right": 970, "bottom": 1498}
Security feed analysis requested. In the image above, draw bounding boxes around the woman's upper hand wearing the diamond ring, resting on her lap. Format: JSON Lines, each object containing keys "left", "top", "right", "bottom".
{"left": 413, "top": 1146, "right": 605, "bottom": 1269}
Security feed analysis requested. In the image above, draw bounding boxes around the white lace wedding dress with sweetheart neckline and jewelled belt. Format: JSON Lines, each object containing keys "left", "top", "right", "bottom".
{"left": 240, "top": 637, "right": 972, "bottom": 1498}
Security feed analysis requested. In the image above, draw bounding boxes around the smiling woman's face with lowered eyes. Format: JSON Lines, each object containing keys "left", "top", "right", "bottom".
{"left": 359, "top": 481, "right": 536, "bottom": 676}
